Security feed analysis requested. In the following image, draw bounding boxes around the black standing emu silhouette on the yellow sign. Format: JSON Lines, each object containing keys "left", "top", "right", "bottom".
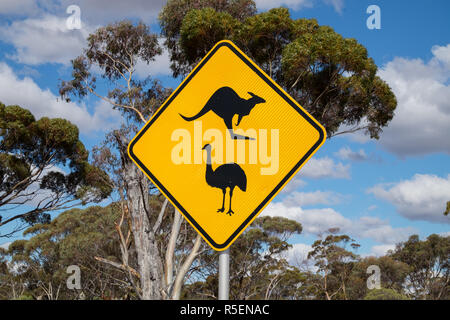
{"left": 202, "top": 144, "right": 247, "bottom": 216}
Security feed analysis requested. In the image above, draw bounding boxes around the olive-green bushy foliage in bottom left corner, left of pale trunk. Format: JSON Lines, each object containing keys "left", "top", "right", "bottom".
{"left": 0, "top": 204, "right": 134, "bottom": 299}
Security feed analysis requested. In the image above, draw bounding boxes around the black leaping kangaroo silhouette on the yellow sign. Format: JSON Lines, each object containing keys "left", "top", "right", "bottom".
{"left": 180, "top": 87, "right": 266, "bottom": 140}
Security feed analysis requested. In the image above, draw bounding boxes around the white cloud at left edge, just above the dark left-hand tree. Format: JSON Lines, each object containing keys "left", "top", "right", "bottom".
{"left": 0, "top": 62, "right": 120, "bottom": 133}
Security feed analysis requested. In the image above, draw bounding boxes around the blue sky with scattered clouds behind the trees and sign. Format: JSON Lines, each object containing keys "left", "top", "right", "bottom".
{"left": 0, "top": 0, "right": 450, "bottom": 256}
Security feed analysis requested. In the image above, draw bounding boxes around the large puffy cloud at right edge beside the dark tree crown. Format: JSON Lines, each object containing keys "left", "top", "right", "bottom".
{"left": 379, "top": 44, "right": 450, "bottom": 156}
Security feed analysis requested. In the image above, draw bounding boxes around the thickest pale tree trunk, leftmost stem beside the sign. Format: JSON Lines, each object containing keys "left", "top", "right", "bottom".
{"left": 118, "top": 137, "right": 163, "bottom": 300}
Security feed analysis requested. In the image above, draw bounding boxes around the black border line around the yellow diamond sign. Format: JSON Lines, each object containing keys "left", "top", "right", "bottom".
{"left": 128, "top": 41, "right": 326, "bottom": 249}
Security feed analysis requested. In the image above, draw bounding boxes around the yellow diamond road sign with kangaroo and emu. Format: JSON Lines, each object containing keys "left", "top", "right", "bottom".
{"left": 128, "top": 41, "right": 326, "bottom": 250}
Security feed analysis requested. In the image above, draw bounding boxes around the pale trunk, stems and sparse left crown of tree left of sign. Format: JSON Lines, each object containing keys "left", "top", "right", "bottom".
{"left": 59, "top": 21, "right": 206, "bottom": 299}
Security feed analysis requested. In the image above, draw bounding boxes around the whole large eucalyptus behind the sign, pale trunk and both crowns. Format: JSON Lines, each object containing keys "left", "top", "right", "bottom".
{"left": 60, "top": 0, "right": 396, "bottom": 299}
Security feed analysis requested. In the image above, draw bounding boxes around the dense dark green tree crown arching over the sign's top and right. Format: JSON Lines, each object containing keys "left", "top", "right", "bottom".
{"left": 160, "top": 0, "right": 397, "bottom": 139}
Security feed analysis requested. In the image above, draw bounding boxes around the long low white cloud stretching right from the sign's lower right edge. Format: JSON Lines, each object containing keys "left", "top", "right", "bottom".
{"left": 262, "top": 202, "right": 416, "bottom": 244}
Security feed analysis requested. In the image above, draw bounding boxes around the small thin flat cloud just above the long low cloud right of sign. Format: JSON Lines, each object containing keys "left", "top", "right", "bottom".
{"left": 283, "top": 191, "right": 343, "bottom": 207}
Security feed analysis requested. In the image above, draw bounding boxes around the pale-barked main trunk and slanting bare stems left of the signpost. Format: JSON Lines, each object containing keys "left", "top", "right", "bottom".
{"left": 117, "top": 132, "right": 201, "bottom": 300}
